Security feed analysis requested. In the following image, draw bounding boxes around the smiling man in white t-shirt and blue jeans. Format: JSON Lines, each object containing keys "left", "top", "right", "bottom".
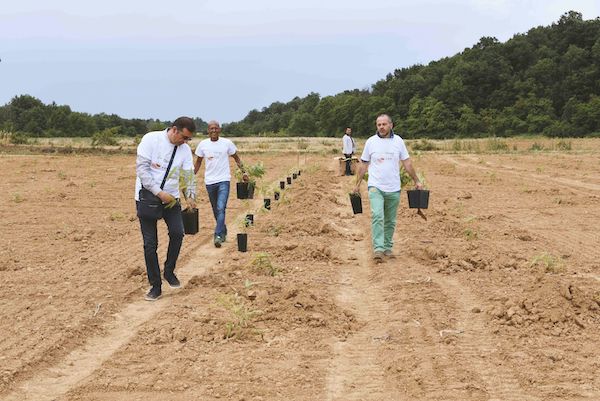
{"left": 194, "top": 120, "right": 249, "bottom": 248}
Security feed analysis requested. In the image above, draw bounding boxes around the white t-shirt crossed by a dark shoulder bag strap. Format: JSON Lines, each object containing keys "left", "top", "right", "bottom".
{"left": 135, "top": 130, "right": 194, "bottom": 200}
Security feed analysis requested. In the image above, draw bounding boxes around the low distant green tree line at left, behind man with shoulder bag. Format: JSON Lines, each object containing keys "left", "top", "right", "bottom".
{"left": 0, "top": 95, "right": 207, "bottom": 137}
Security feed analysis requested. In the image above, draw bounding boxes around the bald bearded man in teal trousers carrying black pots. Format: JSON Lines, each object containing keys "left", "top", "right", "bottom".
{"left": 354, "top": 114, "right": 423, "bottom": 263}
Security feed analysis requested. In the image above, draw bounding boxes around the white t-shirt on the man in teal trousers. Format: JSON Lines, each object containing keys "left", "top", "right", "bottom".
{"left": 360, "top": 134, "right": 409, "bottom": 192}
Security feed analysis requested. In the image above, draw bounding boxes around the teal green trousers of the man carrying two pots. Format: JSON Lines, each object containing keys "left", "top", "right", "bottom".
{"left": 369, "top": 187, "right": 400, "bottom": 252}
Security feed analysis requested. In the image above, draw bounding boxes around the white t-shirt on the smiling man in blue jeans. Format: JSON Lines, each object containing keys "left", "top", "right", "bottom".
{"left": 196, "top": 138, "right": 237, "bottom": 185}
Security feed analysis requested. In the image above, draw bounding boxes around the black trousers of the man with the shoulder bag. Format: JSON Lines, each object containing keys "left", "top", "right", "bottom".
{"left": 136, "top": 202, "right": 183, "bottom": 288}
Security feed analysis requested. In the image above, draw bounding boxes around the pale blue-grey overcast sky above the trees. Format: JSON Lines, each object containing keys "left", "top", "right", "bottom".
{"left": 0, "top": 0, "right": 600, "bottom": 122}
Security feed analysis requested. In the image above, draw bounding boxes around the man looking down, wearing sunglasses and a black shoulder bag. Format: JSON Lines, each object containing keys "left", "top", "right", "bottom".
{"left": 135, "top": 117, "right": 196, "bottom": 301}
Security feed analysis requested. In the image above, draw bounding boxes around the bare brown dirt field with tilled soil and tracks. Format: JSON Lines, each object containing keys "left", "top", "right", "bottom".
{"left": 0, "top": 140, "right": 600, "bottom": 401}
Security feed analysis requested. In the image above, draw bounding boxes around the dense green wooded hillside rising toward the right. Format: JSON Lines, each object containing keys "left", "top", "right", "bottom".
{"left": 223, "top": 11, "right": 600, "bottom": 138}
